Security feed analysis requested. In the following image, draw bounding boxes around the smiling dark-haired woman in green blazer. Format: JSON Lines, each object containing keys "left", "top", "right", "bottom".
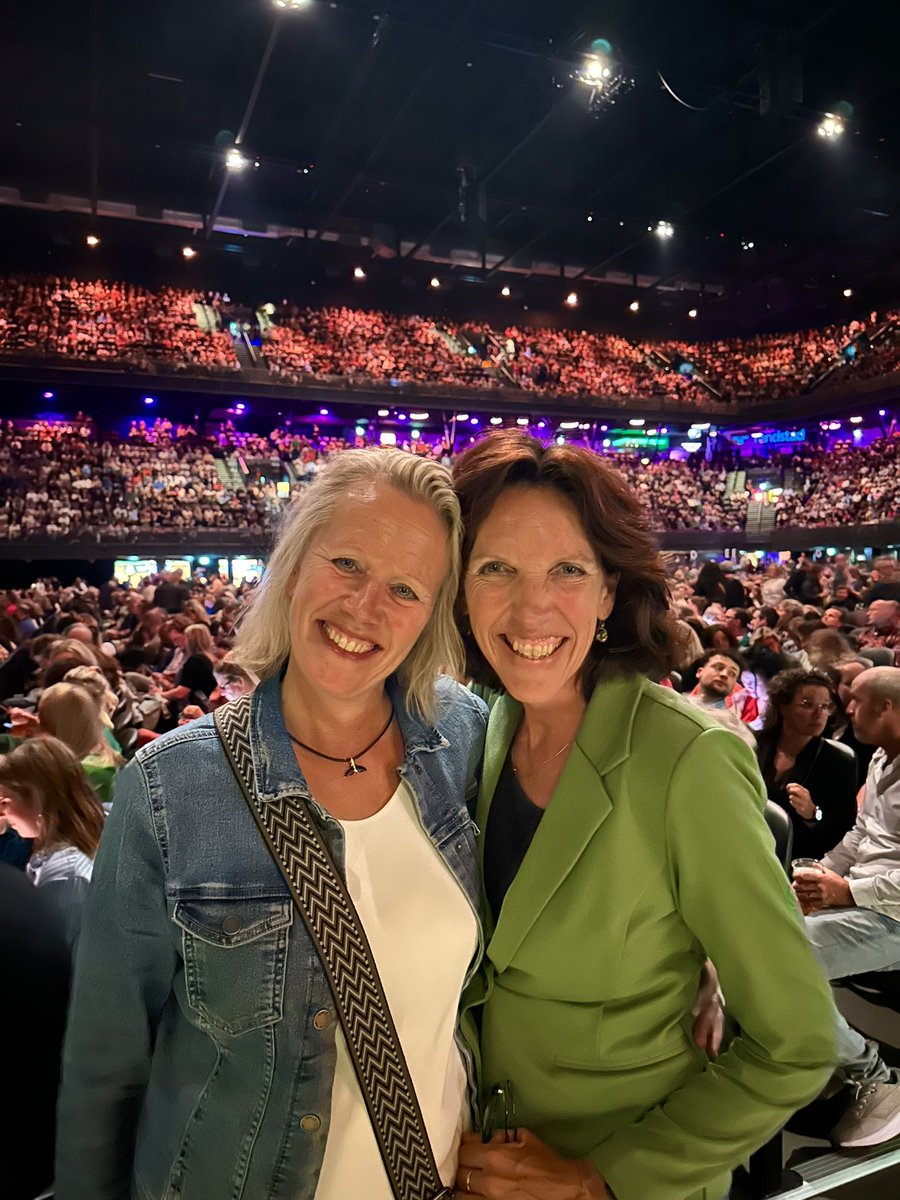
{"left": 455, "top": 431, "right": 833, "bottom": 1200}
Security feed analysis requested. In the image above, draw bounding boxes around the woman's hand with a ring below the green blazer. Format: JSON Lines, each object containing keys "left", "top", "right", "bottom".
{"left": 456, "top": 1129, "right": 608, "bottom": 1200}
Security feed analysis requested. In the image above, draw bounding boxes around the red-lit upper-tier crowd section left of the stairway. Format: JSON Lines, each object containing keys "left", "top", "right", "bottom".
{"left": 0, "top": 275, "right": 240, "bottom": 373}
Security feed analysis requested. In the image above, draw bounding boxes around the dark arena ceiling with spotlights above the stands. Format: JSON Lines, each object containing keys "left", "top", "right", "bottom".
{"left": 0, "top": 0, "right": 900, "bottom": 320}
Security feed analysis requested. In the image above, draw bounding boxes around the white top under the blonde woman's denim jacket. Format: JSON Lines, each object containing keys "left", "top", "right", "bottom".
{"left": 316, "top": 782, "right": 478, "bottom": 1200}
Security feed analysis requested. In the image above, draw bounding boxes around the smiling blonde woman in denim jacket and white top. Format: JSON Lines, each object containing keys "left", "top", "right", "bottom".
{"left": 56, "top": 450, "right": 494, "bottom": 1200}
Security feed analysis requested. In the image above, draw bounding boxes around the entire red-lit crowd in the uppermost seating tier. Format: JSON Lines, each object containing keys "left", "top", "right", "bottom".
{"left": 0, "top": 275, "right": 900, "bottom": 406}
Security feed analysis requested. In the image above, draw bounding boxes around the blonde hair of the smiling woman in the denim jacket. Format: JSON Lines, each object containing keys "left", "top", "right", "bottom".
{"left": 232, "top": 450, "right": 463, "bottom": 718}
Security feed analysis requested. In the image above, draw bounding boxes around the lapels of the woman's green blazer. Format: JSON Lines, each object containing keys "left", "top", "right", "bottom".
{"left": 487, "top": 677, "right": 646, "bottom": 971}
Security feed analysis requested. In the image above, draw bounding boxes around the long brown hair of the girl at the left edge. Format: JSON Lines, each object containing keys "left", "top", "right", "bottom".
{"left": 0, "top": 737, "right": 103, "bottom": 858}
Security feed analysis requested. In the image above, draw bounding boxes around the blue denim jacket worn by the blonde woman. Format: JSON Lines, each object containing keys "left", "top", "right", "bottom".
{"left": 55, "top": 677, "right": 486, "bottom": 1200}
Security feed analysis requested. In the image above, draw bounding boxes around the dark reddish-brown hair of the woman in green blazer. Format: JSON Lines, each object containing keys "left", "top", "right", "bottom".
{"left": 452, "top": 430, "right": 677, "bottom": 698}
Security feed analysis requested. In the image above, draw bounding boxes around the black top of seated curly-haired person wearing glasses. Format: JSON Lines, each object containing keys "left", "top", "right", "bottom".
{"left": 756, "top": 731, "right": 857, "bottom": 858}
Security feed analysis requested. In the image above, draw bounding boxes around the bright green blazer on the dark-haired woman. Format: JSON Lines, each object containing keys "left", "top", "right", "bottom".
{"left": 463, "top": 677, "right": 835, "bottom": 1200}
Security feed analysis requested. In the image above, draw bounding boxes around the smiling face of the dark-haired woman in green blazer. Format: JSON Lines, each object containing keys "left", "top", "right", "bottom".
{"left": 466, "top": 485, "right": 616, "bottom": 704}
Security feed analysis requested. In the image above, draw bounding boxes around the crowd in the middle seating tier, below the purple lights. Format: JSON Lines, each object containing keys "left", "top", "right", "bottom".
{"left": 0, "top": 418, "right": 900, "bottom": 540}
